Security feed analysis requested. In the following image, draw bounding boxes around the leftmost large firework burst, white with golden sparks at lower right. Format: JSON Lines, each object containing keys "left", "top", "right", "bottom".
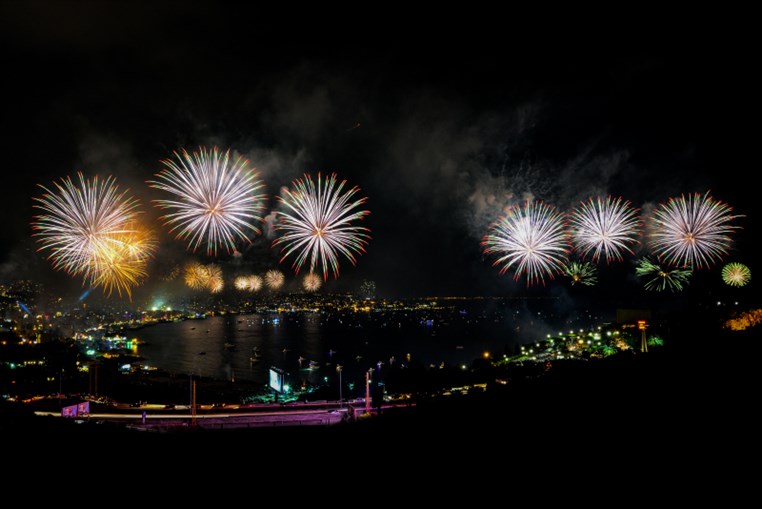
{"left": 32, "top": 172, "right": 156, "bottom": 298}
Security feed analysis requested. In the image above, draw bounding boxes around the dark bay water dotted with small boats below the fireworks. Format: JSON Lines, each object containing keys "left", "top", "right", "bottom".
{"left": 135, "top": 301, "right": 600, "bottom": 385}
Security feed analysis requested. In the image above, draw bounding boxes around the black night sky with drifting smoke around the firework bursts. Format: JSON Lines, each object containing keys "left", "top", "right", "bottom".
{"left": 0, "top": 2, "right": 759, "bottom": 308}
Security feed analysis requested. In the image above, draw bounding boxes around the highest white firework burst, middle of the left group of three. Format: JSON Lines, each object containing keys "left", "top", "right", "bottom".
{"left": 148, "top": 147, "right": 265, "bottom": 256}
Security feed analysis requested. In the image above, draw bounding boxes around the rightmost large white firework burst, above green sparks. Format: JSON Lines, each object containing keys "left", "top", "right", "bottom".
{"left": 651, "top": 191, "right": 743, "bottom": 269}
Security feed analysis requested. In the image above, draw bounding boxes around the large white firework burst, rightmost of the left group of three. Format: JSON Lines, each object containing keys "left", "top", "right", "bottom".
{"left": 273, "top": 173, "right": 370, "bottom": 280}
